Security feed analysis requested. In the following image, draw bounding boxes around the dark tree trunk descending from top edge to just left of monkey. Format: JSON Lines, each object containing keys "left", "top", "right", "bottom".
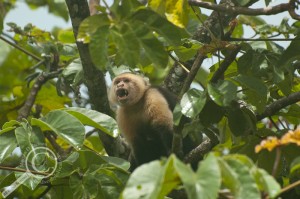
{"left": 66, "top": 0, "right": 129, "bottom": 159}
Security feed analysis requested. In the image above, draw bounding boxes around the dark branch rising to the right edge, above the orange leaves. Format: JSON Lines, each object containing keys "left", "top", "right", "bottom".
{"left": 256, "top": 92, "right": 300, "bottom": 120}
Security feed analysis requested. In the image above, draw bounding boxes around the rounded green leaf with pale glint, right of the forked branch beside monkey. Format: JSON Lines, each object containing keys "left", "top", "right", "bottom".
{"left": 207, "top": 80, "right": 237, "bottom": 106}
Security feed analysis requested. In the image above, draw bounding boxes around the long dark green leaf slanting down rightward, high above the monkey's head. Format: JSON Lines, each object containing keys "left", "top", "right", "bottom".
{"left": 132, "top": 8, "right": 186, "bottom": 46}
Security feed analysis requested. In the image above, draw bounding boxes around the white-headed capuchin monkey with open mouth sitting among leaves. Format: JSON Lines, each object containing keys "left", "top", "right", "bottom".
{"left": 109, "top": 73, "right": 180, "bottom": 170}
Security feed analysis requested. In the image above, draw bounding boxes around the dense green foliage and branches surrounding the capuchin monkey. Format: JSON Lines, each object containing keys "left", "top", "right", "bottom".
{"left": 0, "top": 0, "right": 300, "bottom": 199}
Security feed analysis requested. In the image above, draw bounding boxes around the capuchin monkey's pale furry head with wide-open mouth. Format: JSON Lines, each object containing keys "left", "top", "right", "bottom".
{"left": 111, "top": 74, "right": 147, "bottom": 106}
